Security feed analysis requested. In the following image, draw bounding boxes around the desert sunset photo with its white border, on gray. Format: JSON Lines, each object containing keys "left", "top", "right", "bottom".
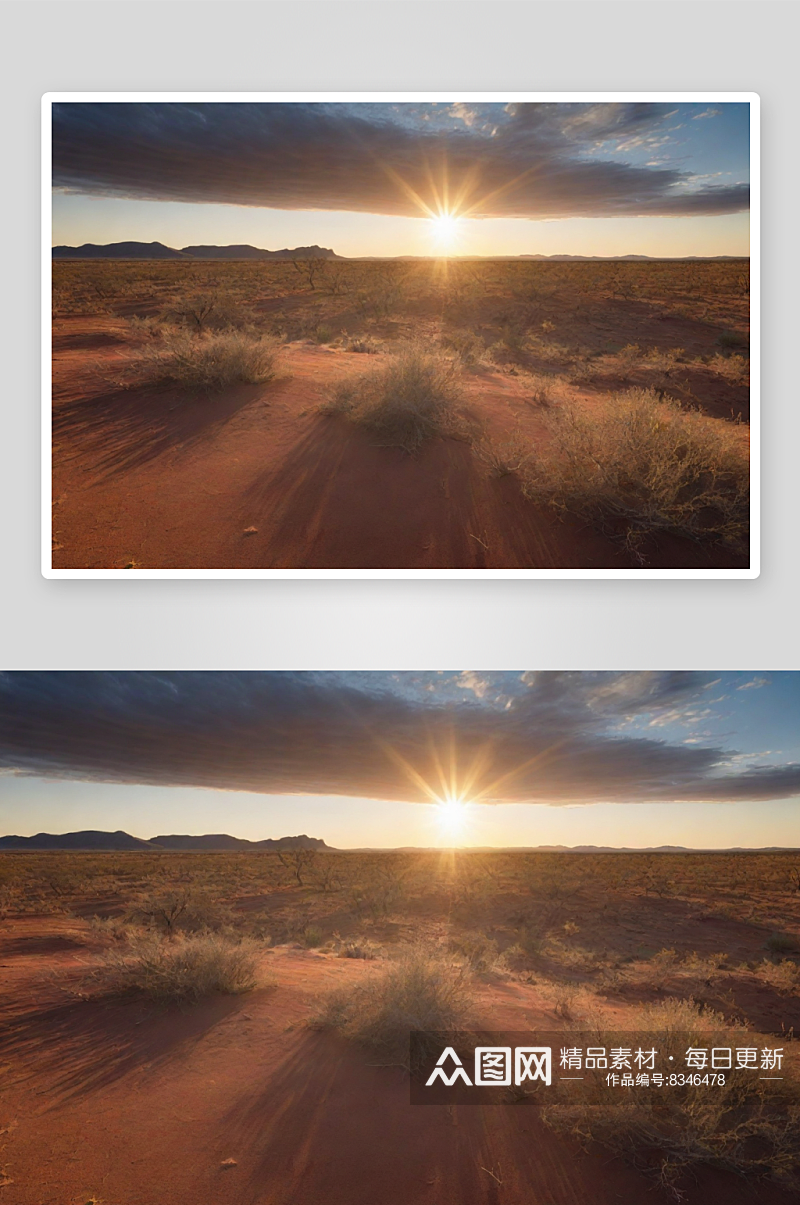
{"left": 42, "top": 92, "right": 759, "bottom": 578}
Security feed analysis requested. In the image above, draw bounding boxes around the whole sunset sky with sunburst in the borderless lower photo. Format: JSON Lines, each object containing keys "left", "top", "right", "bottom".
{"left": 0, "top": 671, "right": 800, "bottom": 848}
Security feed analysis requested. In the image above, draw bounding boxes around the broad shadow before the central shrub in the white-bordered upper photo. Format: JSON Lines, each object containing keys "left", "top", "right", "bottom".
{"left": 242, "top": 418, "right": 620, "bottom": 569}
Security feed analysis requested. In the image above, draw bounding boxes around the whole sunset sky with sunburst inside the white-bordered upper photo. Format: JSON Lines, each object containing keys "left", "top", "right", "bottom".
{"left": 53, "top": 101, "right": 749, "bottom": 257}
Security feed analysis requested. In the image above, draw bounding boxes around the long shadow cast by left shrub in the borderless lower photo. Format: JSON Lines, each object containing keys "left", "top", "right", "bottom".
{"left": 0, "top": 997, "right": 241, "bottom": 1107}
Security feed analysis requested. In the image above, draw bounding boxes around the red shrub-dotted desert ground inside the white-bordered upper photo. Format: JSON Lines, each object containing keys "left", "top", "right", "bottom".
{"left": 53, "top": 252, "right": 749, "bottom": 569}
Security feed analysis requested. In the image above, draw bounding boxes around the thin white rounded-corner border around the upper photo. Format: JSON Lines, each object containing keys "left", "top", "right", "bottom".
{"left": 41, "top": 90, "right": 760, "bottom": 581}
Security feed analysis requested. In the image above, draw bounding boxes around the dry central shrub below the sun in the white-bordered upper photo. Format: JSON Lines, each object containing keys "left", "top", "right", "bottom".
{"left": 322, "top": 343, "right": 466, "bottom": 453}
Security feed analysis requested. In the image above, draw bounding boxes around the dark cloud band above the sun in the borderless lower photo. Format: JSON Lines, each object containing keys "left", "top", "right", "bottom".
{"left": 0, "top": 672, "right": 800, "bottom": 804}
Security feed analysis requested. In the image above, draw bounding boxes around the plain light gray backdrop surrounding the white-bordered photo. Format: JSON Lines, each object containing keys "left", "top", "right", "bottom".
{"left": 0, "top": 0, "right": 800, "bottom": 669}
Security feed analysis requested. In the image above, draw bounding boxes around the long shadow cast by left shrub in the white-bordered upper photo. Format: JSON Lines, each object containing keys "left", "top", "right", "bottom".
{"left": 53, "top": 384, "right": 272, "bottom": 480}
